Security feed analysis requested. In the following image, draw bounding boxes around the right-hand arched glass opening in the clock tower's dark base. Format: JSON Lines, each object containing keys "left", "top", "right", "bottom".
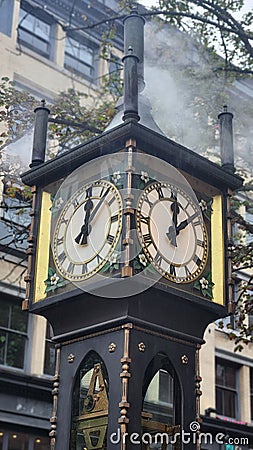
{"left": 142, "top": 353, "right": 181, "bottom": 450}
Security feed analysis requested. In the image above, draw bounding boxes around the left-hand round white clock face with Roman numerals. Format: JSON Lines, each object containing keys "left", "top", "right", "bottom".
{"left": 52, "top": 180, "right": 122, "bottom": 282}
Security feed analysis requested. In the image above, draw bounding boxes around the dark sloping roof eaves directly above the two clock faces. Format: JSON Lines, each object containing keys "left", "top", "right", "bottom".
{"left": 22, "top": 120, "right": 242, "bottom": 190}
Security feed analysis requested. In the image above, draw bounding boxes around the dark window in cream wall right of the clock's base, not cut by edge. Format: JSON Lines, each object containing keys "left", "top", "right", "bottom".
{"left": 216, "top": 360, "right": 238, "bottom": 418}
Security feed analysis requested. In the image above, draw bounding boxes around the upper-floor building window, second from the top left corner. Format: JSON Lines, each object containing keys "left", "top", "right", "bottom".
{"left": 64, "top": 36, "right": 98, "bottom": 83}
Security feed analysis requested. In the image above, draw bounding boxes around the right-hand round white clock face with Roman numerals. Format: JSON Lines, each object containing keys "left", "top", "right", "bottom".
{"left": 136, "top": 182, "right": 208, "bottom": 283}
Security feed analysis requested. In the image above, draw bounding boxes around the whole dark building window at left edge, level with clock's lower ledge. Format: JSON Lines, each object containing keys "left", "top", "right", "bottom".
{"left": 0, "top": 300, "right": 28, "bottom": 369}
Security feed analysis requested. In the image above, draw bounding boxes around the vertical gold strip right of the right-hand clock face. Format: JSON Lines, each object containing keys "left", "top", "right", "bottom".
{"left": 211, "top": 195, "right": 225, "bottom": 305}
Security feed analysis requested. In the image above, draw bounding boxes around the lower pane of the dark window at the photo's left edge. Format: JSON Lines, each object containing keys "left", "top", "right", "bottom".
{"left": 6, "top": 333, "right": 25, "bottom": 369}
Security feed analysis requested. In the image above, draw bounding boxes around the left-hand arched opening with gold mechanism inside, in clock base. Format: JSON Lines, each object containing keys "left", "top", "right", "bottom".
{"left": 71, "top": 352, "right": 109, "bottom": 450}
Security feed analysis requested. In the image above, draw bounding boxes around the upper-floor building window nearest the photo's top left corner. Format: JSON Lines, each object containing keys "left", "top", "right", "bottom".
{"left": 18, "top": 2, "right": 53, "bottom": 59}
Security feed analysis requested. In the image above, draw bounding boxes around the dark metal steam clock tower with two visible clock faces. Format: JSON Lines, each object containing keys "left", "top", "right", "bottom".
{"left": 23, "top": 7, "right": 241, "bottom": 450}
